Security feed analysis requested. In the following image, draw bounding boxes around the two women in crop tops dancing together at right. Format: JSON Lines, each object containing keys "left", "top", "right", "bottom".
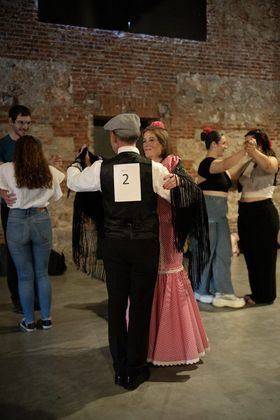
{"left": 195, "top": 128, "right": 279, "bottom": 308}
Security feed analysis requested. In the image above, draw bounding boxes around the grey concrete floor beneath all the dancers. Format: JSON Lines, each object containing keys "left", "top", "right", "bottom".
{"left": 0, "top": 255, "right": 280, "bottom": 420}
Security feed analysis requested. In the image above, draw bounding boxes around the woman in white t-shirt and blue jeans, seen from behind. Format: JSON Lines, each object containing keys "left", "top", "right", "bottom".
{"left": 0, "top": 136, "right": 64, "bottom": 332}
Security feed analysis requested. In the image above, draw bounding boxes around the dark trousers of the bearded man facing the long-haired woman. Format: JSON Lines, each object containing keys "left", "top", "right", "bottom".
{"left": 1, "top": 201, "right": 19, "bottom": 304}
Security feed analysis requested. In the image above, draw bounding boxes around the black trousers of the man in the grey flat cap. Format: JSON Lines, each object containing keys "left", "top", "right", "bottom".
{"left": 102, "top": 238, "right": 159, "bottom": 376}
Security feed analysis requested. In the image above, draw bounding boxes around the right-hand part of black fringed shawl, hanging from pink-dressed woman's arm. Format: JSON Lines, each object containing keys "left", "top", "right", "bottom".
{"left": 170, "top": 158, "right": 210, "bottom": 289}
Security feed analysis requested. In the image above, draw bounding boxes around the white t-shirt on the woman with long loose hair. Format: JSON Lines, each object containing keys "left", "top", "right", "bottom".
{"left": 0, "top": 162, "right": 65, "bottom": 209}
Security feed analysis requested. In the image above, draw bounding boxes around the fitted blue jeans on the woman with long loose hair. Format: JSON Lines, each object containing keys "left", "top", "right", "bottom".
{"left": 7, "top": 208, "right": 52, "bottom": 323}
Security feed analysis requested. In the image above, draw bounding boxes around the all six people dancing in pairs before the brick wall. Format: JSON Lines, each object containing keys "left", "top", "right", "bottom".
{"left": 0, "top": 105, "right": 279, "bottom": 390}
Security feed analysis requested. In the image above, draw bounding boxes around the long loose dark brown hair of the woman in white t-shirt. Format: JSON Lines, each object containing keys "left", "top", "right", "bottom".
{"left": 14, "top": 136, "right": 52, "bottom": 190}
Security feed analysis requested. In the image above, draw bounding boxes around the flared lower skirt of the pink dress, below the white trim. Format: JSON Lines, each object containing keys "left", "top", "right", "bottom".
{"left": 147, "top": 270, "right": 209, "bottom": 366}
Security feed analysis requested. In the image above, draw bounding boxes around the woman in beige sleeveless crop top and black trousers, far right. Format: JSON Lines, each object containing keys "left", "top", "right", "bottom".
{"left": 238, "top": 129, "right": 279, "bottom": 305}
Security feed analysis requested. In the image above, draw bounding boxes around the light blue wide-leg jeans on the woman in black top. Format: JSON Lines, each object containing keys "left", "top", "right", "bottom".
{"left": 197, "top": 196, "right": 234, "bottom": 295}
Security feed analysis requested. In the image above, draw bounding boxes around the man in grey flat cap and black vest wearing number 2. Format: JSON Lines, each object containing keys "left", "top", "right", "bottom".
{"left": 67, "top": 113, "right": 174, "bottom": 390}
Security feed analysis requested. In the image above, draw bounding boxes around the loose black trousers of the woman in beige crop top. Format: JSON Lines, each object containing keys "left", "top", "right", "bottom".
{"left": 238, "top": 199, "right": 279, "bottom": 303}
